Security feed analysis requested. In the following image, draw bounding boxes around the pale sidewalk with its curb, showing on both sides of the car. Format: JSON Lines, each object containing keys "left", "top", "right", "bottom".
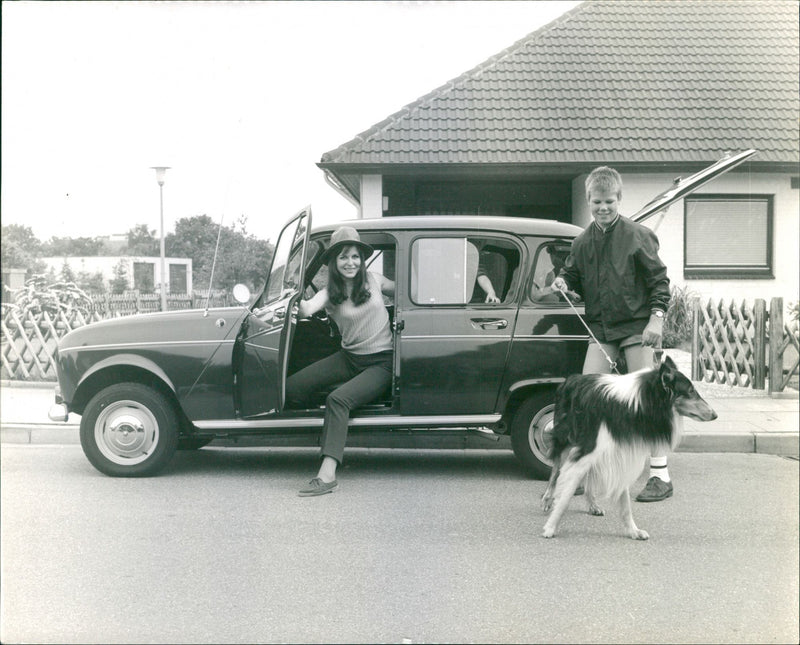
{"left": 0, "top": 374, "right": 800, "bottom": 456}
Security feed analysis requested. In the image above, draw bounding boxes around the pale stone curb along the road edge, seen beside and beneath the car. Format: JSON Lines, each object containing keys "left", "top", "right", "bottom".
{"left": 0, "top": 423, "right": 800, "bottom": 457}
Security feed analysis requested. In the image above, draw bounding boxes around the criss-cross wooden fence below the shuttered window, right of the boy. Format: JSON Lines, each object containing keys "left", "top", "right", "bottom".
{"left": 692, "top": 298, "right": 800, "bottom": 392}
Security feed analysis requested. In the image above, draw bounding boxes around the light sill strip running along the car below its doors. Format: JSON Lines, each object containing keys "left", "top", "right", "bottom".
{"left": 194, "top": 414, "right": 501, "bottom": 431}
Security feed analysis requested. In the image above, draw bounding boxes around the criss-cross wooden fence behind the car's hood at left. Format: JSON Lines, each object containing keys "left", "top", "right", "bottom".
{"left": 0, "top": 292, "right": 234, "bottom": 381}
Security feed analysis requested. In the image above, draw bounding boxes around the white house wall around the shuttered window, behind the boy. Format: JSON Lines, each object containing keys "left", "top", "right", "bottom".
{"left": 572, "top": 172, "right": 800, "bottom": 303}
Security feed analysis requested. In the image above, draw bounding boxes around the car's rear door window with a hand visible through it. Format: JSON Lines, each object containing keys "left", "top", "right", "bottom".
{"left": 411, "top": 237, "right": 520, "bottom": 305}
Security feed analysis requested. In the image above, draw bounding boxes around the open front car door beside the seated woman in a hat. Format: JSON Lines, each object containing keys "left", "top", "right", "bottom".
{"left": 234, "top": 207, "right": 311, "bottom": 418}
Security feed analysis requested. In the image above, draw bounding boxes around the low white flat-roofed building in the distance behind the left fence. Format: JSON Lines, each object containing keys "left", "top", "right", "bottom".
{"left": 42, "top": 255, "right": 192, "bottom": 294}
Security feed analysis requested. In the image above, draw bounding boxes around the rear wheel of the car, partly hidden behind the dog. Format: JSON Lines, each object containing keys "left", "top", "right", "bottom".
{"left": 511, "top": 390, "right": 555, "bottom": 479}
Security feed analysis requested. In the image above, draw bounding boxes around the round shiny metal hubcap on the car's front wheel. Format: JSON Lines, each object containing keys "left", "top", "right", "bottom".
{"left": 94, "top": 401, "right": 158, "bottom": 466}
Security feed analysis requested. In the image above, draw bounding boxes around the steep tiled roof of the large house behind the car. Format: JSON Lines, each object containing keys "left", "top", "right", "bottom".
{"left": 321, "top": 0, "right": 800, "bottom": 166}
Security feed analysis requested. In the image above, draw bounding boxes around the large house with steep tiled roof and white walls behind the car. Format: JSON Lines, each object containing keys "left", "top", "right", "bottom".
{"left": 318, "top": 0, "right": 800, "bottom": 301}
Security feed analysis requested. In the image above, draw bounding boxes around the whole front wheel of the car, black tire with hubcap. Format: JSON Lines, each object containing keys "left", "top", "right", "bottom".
{"left": 80, "top": 383, "right": 178, "bottom": 477}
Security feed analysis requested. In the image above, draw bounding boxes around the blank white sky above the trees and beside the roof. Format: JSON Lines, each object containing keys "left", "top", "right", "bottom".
{"left": 0, "top": 0, "right": 579, "bottom": 241}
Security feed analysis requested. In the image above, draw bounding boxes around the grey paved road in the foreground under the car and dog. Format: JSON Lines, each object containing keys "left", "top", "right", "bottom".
{"left": 0, "top": 445, "right": 799, "bottom": 643}
